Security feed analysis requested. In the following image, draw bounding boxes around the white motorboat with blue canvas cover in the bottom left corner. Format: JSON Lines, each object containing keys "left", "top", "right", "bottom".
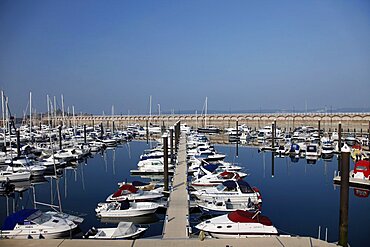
{"left": 0, "top": 209, "right": 78, "bottom": 239}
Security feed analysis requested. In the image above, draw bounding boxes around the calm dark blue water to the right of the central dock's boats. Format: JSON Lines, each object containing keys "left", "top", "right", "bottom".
{"left": 216, "top": 146, "right": 370, "bottom": 247}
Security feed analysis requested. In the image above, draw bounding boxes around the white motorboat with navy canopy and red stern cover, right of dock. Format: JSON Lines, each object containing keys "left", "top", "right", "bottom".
{"left": 191, "top": 180, "right": 262, "bottom": 204}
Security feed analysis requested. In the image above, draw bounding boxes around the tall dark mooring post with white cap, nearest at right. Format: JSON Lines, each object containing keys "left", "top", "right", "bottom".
{"left": 339, "top": 146, "right": 350, "bottom": 246}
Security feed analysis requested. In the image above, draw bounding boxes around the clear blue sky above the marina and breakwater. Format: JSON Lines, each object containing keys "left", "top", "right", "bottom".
{"left": 0, "top": 0, "right": 370, "bottom": 114}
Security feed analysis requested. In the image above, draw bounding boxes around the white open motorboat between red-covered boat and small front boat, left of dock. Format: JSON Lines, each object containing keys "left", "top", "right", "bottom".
{"left": 95, "top": 200, "right": 159, "bottom": 218}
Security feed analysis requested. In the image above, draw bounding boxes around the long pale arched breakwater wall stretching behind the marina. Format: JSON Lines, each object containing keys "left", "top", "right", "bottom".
{"left": 49, "top": 112, "right": 370, "bottom": 133}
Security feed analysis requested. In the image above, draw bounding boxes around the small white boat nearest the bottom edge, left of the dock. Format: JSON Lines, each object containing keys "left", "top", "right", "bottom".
{"left": 84, "top": 222, "right": 148, "bottom": 239}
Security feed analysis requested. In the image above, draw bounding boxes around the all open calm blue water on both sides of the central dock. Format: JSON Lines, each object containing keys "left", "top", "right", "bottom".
{"left": 0, "top": 141, "right": 370, "bottom": 247}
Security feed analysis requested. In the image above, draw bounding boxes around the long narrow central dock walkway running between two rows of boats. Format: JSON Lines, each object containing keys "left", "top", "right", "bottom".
{"left": 162, "top": 135, "right": 189, "bottom": 239}
